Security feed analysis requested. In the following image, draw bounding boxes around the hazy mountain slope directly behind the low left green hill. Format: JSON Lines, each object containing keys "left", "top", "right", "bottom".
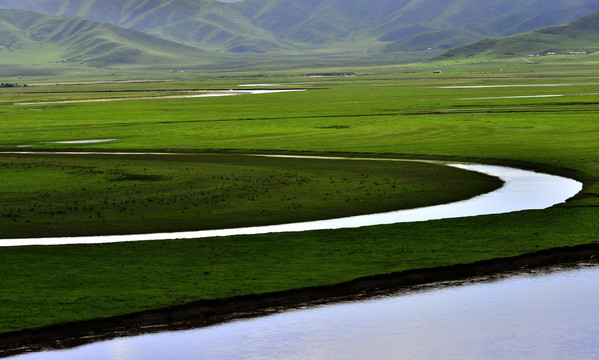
{"left": 0, "top": 0, "right": 285, "bottom": 51}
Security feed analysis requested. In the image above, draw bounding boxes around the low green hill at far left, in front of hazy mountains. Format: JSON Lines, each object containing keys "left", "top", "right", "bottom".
{"left": 0, "top": 9, "right": 202, "bottom": 66}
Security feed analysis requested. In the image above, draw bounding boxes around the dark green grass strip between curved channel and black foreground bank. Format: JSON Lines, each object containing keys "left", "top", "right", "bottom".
{"left": 0, "top": 207, "right": 597, "bottom": 331}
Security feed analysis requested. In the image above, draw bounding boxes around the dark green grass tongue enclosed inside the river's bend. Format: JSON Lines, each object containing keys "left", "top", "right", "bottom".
{"left": 0, "top": 154, "right": 501, "bottom": 241}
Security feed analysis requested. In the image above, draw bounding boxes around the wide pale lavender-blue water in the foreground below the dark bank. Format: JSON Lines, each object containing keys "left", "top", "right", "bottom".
{"left": 14, "top": 264, "right": 599, "bottom": 360}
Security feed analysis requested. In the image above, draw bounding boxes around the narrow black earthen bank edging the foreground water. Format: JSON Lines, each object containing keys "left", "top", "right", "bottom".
{"left": 0, "top": 243, "right": 599, "bottom": 357}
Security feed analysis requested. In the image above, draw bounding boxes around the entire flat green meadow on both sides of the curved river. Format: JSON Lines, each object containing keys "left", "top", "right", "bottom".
{"left": 0, "top": 55, "right": 599, "bottom": 332}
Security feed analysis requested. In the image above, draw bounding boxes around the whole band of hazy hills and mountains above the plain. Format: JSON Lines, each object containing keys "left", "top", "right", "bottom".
{"left": 0, "top": 0, "right": 599, "bottom": 74}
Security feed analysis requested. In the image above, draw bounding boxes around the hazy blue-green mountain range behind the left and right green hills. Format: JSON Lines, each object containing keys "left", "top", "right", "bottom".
{"left": 0, "top": 0, "right": 599, "bottom": 52}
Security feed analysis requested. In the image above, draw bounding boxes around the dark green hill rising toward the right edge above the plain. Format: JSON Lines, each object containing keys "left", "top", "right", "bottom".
{"left": 436, "top": 12, "right": 599, "bottom": 60}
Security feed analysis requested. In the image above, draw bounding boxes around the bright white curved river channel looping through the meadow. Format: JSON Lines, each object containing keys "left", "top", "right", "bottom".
{"left": 0, "top": 152, "right": 582, "bottom": 247}
